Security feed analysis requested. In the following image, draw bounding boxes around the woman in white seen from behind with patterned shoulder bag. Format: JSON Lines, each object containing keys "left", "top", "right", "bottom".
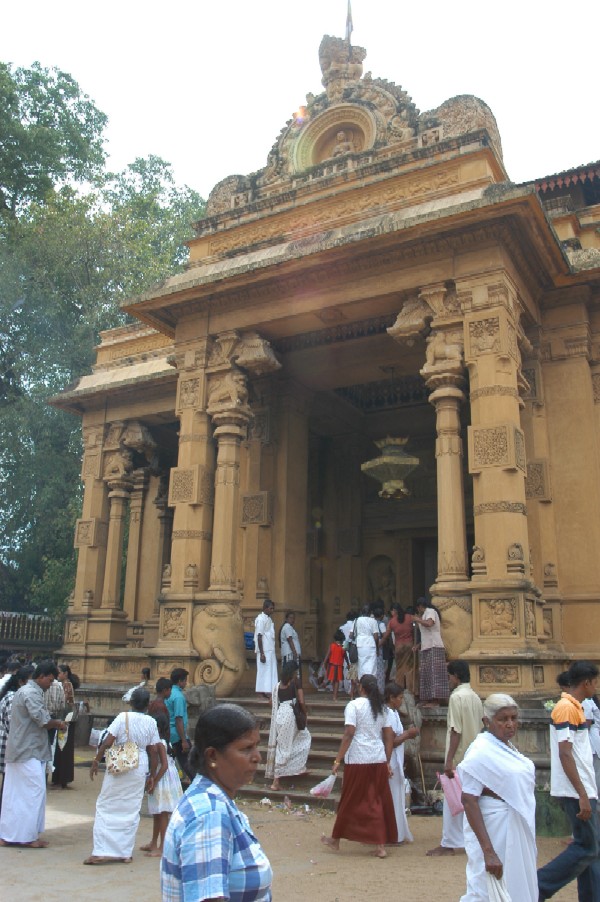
{"left": 83, "top": 689, "right": 160, "bottom": 864}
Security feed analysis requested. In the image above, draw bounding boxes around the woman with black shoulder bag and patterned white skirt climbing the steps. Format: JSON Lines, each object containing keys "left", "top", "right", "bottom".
{"left": 265, "top": 661, "right": 311, "bottom": 792}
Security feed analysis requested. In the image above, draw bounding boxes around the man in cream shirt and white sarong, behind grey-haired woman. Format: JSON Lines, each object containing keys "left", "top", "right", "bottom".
{"left": 427, "top": 661, "right": 483, "bottom": 858}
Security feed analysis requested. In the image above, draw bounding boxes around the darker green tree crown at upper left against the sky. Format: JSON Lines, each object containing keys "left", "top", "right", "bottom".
{"left": 0, "top": 63, "right": 107, "bottom": 218}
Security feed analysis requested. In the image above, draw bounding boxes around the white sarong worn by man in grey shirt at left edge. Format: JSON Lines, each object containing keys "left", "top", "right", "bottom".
{"left": 0, "top": 758, "right": 46, "bottom": 843}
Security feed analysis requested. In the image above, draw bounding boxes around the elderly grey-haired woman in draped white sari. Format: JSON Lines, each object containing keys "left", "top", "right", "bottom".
{"left": 457, "top": 693, "right": 538, "bottom": 902}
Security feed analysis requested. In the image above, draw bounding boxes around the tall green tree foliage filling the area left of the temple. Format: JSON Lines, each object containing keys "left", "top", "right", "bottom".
{"left": 0, "top": 64, "right": 204, "bottom": 611}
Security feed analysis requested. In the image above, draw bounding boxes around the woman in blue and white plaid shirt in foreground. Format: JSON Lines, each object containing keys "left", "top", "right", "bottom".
{"left": 161, "top": 704, "right": 273, "bottom": 902}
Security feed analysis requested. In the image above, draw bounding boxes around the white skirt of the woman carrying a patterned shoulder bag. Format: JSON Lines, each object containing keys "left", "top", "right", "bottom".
{"left": 92, "top": 767, "right": 146, "bottom": 858}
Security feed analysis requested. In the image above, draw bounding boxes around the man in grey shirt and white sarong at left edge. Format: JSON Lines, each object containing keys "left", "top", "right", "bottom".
{"left": 0, "top": 661, "right": 68, "bottom": 849}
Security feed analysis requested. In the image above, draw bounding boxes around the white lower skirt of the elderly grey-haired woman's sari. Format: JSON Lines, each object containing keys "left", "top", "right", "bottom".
{"left": 460, "top": 796, "right": 538, "bottom": 902}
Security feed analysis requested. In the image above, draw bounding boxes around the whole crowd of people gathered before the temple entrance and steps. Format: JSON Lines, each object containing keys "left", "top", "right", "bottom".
{"left": 0, "top": 636, "right": 600, "bottom": 902}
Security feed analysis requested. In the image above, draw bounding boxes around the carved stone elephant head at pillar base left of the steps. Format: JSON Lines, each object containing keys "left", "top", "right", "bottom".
{"left": 192, "top": 603, "right": 246, "bottom": 697}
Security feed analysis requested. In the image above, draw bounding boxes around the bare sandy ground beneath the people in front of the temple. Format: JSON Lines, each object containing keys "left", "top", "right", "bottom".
{"left": 0, "top": 767, "right": 577, "bottom": 902}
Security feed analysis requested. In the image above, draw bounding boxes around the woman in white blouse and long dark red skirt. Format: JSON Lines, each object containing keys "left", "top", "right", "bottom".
{"left": 321, "top": 674, "right": 398, "bottom": 858}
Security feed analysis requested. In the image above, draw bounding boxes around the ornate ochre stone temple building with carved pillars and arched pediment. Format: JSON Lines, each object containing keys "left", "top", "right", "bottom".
{"left": 52, "top": 37, "right": 600, "bottom": 696}
